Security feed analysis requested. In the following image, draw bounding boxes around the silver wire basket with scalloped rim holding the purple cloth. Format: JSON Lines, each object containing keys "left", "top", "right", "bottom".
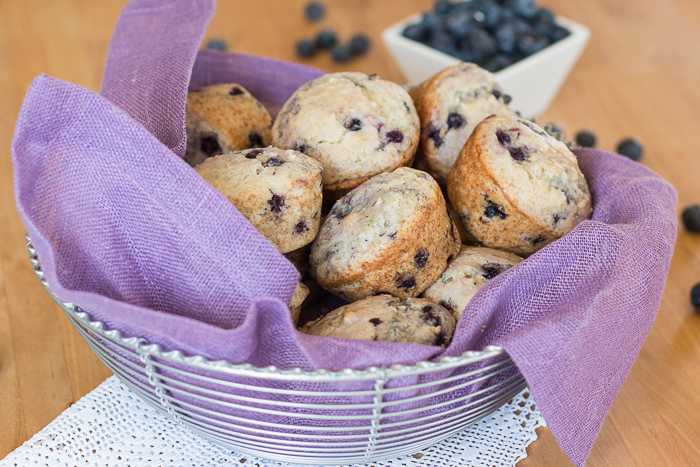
{"left": 27, "top": 237, "right": 525, "bottom": 465}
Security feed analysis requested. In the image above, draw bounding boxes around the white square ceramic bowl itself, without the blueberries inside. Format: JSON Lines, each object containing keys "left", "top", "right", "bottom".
{"left": 382, "top": 13, "right": 591, "bottom": 117}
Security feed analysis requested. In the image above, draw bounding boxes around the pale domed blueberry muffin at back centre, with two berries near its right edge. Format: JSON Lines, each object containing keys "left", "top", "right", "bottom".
{"left": 272, "top": 73, "right": 420, "bottom": 200}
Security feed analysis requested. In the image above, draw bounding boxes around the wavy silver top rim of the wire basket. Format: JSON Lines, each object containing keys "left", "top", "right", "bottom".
{"left": 25, "top": 234, "right": 510, "bottom": 382}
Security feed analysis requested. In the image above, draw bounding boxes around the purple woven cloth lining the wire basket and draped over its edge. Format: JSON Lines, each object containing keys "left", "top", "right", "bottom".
{"left": 12, "top": 0, "right": 676, "bottom": 466}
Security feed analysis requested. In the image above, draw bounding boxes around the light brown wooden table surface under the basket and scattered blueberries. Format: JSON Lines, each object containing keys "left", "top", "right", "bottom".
{"left": 0, "top": 0, "right": 700, "bottom": 467}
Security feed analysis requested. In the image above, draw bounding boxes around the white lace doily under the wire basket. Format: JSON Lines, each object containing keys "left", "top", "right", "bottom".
{"left": 0, "top": 376, "right": 545, "bottom": 467}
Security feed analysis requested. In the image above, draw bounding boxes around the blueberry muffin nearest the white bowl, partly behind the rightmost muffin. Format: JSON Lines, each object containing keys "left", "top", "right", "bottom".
{"left": 409, "top": 63, "right": 513, "bottom": 186}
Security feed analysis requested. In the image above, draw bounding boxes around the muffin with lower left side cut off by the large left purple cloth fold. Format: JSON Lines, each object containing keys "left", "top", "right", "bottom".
{"left": 195, "top": 147, "right": 323, "bottom": 253}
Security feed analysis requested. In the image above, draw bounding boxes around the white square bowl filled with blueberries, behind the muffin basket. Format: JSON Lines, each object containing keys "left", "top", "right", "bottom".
{"left": 382, "top": 0, "right": 590, "bottom": 117}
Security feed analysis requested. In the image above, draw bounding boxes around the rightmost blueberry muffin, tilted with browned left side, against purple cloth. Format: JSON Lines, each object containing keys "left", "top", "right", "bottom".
{"left": 447, "top": 116, "right": 592, "bottom": 255}
